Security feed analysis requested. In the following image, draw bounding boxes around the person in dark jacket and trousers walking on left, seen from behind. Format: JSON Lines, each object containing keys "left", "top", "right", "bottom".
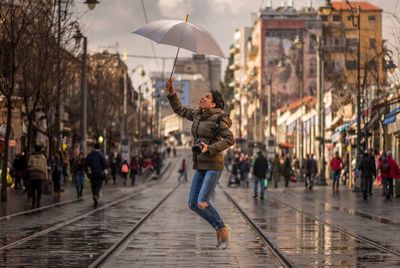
{"left": 85, "top": 143, "right": 107, "bottom": 206}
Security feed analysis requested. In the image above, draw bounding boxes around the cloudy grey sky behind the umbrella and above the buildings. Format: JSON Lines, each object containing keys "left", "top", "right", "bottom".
{"left": 73, "top": 0, "right": 400, "bottom": 89}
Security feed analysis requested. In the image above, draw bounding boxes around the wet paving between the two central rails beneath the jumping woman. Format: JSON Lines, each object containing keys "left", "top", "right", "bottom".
{"left": 108, "top": 181, "right": 277, "bottom": 267}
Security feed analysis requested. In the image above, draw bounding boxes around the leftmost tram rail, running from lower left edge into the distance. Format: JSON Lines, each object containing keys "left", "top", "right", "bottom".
{"left": 0, "top": 161, "right": 174, "bottom": 252}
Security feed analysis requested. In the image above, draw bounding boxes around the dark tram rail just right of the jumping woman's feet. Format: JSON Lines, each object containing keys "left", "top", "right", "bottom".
{"left": 218, "top": 184, "right": 296, "bottom": 268}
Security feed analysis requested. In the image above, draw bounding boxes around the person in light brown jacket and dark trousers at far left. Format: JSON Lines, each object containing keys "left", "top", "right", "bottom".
{"left": 28, "top": 144, "right": 48, "bottom": 208}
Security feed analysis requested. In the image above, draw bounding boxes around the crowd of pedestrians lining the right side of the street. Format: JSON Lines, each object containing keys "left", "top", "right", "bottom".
{"left": 225, "top": 150, "right": 400, "bottom": 200}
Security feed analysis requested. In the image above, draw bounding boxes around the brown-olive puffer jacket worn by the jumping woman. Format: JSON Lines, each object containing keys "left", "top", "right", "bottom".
{"left": 168, "top": 93, "right": 235, "bottom": 170}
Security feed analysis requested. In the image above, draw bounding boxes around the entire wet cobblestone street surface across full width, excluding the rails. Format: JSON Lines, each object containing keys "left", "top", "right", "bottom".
{"left": 0, "top": 153, "right": 400, "bottom": 267}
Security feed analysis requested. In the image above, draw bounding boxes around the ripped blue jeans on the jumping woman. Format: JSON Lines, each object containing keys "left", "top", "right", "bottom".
{"left": 189, "top": 170, "right": 224, "bottom": 230}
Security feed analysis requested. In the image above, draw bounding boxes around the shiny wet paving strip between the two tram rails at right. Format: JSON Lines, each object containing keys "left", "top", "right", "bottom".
{"left": 223, "top": 182, "right": 400, "bottom": 267}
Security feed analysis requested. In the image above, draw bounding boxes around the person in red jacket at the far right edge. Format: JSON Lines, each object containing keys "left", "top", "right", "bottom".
{"left": 379, "top": 151, "right": 399, "bottom": 200}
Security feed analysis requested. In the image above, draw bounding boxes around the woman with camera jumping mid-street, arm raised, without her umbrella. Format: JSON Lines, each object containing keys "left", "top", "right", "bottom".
{"left": 166, "top": 79, "right": 234, "bottom": 249}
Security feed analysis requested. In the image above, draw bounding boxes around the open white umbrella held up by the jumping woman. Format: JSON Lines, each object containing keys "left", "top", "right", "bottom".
{"left": 133, "top": 15, "right": 224, "bottom": 78}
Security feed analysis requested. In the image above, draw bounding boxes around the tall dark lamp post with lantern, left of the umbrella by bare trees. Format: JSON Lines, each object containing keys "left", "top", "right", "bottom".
{"left": 73, "top": 27, "right": 87, "bottom": 155}
